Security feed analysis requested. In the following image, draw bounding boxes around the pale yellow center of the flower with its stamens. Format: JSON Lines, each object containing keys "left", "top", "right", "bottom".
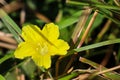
{"left": 36, "top": 43, "right": 48, "bottom": 55}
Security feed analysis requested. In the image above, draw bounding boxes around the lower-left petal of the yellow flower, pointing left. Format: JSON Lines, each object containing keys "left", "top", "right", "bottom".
{"left": 14, "top": 42, "right": 35, "bottom": 59}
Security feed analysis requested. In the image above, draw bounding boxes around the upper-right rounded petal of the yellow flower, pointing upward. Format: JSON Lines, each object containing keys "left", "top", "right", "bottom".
{"left": 42, "top": 23, "right": 59, "bottom": 41}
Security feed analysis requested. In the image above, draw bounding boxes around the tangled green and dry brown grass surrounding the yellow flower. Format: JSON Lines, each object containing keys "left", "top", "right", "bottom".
{"left": 0, "top": 0, "right": 120, "bottom": 80}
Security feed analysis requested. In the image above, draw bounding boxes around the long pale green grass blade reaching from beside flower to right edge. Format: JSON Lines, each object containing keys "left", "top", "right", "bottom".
{"left": 74, "top": 39, "right": 120, "bottom": 52}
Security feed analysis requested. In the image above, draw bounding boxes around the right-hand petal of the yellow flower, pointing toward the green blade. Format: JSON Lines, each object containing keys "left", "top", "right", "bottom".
{"left": 49, "top": 39, "right": 70, "bottom": 55}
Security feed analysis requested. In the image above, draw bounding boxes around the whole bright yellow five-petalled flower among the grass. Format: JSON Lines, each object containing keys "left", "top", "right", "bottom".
{"left": 14, "top": 23, "right": 69, "bottom": 69}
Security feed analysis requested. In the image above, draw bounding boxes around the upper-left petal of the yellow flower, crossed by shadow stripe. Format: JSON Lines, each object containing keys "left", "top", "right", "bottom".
{"left": 22, "top": 25, "right": 42, "bottom": 43}
